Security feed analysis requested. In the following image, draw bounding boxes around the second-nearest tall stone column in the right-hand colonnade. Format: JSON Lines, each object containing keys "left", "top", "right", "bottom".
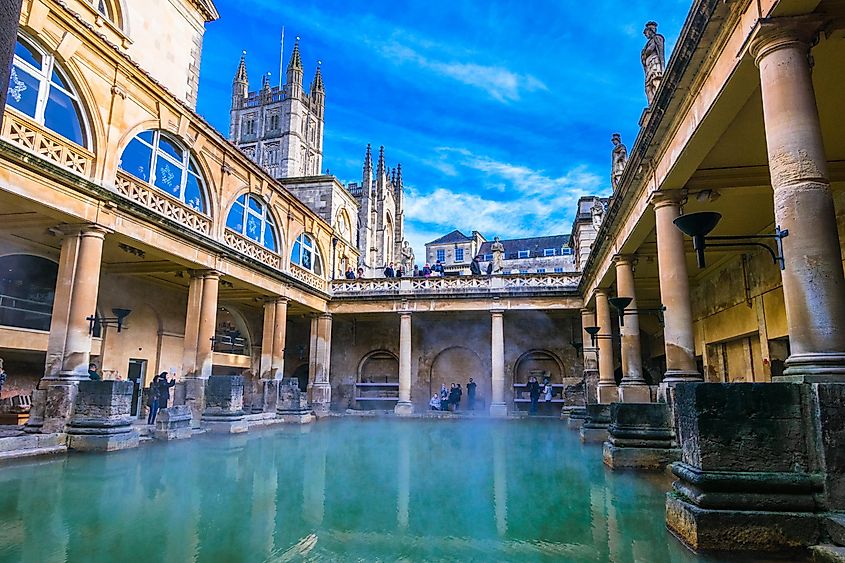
{"left": 652, "top": 190, "right": 702, "bottom": 390}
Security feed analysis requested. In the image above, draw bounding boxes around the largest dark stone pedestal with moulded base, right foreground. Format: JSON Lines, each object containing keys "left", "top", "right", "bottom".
{"left": 666, "top": 383, "right": 824, "bottom": 551}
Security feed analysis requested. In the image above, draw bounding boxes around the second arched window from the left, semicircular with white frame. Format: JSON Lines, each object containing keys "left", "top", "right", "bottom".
{"left": 119, "top": 131, "right": 206, "bottom": 213}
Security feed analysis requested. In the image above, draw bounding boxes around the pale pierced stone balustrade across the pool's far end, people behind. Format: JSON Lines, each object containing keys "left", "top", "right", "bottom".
{"left": 331, "top": 272, "right": 581, "bottom": 299}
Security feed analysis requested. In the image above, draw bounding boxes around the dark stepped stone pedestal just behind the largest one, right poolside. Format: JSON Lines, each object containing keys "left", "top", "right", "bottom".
{"left": 603, "top": 403, "right": 681, "bottom": 471}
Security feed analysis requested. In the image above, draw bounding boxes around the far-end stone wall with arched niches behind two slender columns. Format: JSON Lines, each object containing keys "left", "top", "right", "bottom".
{"left": 330, "top": 311, "right": 583, "bottom": 410}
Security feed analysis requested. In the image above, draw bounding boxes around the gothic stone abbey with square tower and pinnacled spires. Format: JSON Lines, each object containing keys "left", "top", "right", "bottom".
{"left": 229, "top": 42, "right": 413, "bottom": 277}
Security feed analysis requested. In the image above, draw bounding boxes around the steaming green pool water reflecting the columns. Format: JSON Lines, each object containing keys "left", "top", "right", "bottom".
{"left": 0, "top": 418, "right": 712, "bottom": 562}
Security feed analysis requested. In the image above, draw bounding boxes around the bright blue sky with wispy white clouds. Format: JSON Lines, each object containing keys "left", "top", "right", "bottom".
{"left": 198, "top": 0, "right": 690, "bottom": 256}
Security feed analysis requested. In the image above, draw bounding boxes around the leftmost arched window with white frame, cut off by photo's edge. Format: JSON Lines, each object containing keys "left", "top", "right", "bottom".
{"left": 7, "top": 35, "right": 88, "bottom": 147}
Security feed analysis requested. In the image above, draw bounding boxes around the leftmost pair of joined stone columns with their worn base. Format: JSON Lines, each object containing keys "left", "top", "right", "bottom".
{"left": 27, "top": 225, "right": 107, "bottom": 433}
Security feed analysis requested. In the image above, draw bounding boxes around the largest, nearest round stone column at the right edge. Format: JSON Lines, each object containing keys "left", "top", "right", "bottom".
{"left": 751, "top": 16, "right": 845, "bottom": 382}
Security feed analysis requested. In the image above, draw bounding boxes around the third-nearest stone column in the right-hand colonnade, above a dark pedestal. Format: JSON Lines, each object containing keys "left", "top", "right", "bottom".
{"left": 614, "top": 256, "right": 651, "bottom": 403}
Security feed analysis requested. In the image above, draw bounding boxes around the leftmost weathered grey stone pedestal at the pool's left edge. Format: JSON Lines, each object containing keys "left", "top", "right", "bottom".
{"left": 67, "top": 380, "right": 140, "bottom": 452}
